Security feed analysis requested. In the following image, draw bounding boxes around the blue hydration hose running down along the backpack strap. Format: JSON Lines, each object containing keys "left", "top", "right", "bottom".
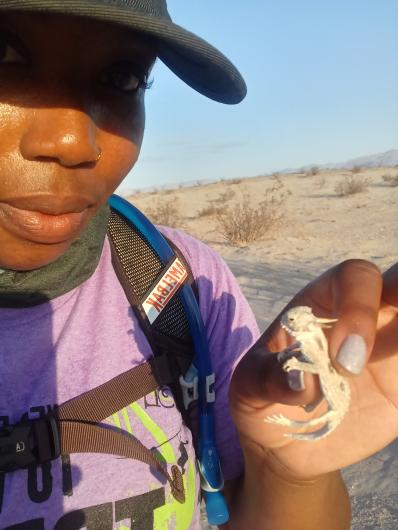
{"left": 108, "top": 195, "right": 229, "bottom": 525}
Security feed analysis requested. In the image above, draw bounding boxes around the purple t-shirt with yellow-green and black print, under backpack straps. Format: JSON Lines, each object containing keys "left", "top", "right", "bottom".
{"left": 0, "top": 228, "right": 258, "bottom": 530}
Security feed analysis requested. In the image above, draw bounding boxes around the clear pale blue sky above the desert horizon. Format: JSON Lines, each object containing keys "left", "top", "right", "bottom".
{"left": 121, "top": 0, "right": 398, "bottom": 190}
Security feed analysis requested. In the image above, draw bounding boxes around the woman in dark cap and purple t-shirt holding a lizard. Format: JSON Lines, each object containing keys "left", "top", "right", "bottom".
{"left": 0, "top": 0, "right": 398, "bottom": 530}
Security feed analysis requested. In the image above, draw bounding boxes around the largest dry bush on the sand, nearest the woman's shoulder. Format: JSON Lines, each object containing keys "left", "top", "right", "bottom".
{"left": 217, "top": 184, "right": 287, "bottom": 245}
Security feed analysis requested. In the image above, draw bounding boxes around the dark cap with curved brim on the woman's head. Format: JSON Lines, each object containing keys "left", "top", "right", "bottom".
{"left": 0, "top": 0, "right": 246, "bottom": 104}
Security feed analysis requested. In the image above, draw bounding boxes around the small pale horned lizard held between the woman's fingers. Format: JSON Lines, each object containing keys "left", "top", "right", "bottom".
{"left": 264, "top": 306, "right": 350, "bottom": 440}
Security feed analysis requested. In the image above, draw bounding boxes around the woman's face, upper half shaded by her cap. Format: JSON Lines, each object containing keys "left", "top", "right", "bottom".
{"left": 0, "top": 13, "right": 155, "bottom": 270}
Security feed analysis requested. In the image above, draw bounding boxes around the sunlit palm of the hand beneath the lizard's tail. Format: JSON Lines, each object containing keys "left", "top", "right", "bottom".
{"left": 234, "top": 356, "right": 398, "bottom": 478}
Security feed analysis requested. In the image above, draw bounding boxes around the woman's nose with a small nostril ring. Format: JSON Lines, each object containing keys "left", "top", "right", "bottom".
{"left": 20, "top": 108, "right": 101, "bottom": 167}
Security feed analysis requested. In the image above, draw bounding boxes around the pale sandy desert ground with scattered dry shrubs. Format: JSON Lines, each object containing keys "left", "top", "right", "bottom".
{"left": 128, "top": 167, "right": 398, "bottom": 530}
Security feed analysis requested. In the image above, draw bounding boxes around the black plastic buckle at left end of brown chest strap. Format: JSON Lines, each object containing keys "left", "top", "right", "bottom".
{"left": 0, "top": 416, "right": 61, "bottom": 473}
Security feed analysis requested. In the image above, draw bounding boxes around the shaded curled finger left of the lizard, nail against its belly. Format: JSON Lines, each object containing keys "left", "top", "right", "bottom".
{"left": 231, "top": 343, "right": 320, "bottom": 409}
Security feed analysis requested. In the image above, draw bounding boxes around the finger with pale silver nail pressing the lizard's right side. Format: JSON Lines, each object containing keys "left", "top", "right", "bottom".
{"left": 326, "top": 260, "right": 382, "bottom": 375}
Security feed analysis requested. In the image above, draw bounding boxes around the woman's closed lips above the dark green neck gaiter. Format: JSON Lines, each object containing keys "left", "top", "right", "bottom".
{"left": 0, "top": 195, "right": 93, "bottom": 244}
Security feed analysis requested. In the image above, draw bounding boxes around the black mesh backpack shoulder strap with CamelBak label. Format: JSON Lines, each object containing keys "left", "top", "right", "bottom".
{"left": 108, "top": 196, "right": 197, "bottom": 422}
